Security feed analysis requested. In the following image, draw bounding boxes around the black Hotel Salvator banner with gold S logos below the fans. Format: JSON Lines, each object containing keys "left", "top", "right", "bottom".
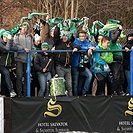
{"left": 11, "top": 96, "right": 133, "bottom": 133}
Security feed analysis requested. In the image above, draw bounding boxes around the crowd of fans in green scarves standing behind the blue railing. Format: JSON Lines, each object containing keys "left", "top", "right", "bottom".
{"left": 0, "top": 16, "right": 133, "bottom": 97}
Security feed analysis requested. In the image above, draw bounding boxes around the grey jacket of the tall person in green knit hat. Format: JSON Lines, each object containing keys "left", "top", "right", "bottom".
{"left": 14, "top": 33, "right": 34, "bottom": 63}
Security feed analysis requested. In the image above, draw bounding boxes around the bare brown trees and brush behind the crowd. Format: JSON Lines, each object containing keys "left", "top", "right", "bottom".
{"left": 0, "top": 0, "right": 133, "bottom": 28}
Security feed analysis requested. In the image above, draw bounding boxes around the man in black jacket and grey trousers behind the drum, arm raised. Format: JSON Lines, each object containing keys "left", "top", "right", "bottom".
{"left": 54, "top": 27, "right": 80, "bottom": 96}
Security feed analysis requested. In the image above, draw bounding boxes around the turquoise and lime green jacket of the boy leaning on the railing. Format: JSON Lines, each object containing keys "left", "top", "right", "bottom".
{"left": 92, "top": 42, "right": 113, "bottom": 77}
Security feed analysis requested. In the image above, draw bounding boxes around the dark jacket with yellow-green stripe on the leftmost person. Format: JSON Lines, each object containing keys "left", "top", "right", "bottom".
{"left": 0, "top": 38, "right": 13, "bottom": 67}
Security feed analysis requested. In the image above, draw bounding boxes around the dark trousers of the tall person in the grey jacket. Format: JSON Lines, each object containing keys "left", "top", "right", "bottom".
{"left": 16, "top": 61, "right": 27, "bottom": 96}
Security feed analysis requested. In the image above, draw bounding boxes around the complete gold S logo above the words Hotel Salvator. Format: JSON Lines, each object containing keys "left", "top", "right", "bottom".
{"left": 44, "top": 99, "right": 62, "bottom": 117}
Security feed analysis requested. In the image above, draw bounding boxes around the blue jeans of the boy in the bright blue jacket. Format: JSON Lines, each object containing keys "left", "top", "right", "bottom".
{"left": 72, "top": 67, "right": 92, "bottom": 96}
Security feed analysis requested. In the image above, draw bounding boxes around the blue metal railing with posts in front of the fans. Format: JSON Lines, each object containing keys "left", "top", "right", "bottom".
{"left": 4, "top": 50, "right": 133, "bottom": 97}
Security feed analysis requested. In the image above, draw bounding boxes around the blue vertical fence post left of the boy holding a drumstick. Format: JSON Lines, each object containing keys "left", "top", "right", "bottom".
{"left": 27, "top": 52, "right": 31, "bottom": 97}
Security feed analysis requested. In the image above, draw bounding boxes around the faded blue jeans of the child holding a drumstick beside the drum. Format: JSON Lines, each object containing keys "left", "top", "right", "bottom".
{"left": 38, "top": 72, "right": 51, "bottom": 97}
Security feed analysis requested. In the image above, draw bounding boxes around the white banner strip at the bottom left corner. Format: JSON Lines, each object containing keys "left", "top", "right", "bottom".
{"left": 0, "top": 97, "right": 4, "bottom": 133}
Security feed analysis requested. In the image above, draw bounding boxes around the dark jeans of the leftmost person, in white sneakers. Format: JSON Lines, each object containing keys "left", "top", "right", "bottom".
{"left": 0, "top": 65, "right": 14, "bottom": 92}
